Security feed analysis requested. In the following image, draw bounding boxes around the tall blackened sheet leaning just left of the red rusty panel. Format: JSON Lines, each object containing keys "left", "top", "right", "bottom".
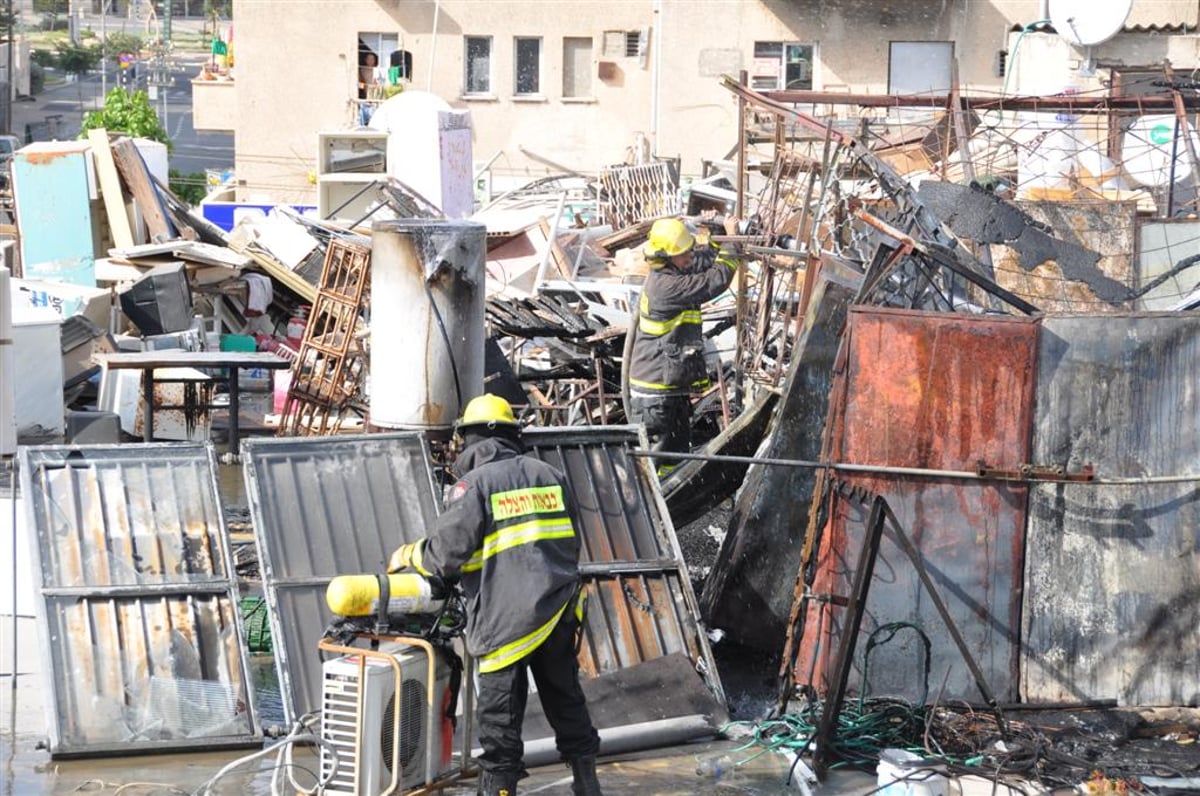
{"left": 701, "top": 258, "right": 862, "bottom": 653}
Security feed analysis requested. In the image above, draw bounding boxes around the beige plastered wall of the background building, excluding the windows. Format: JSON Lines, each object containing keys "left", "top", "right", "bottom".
{"left": 223, "top": 0, "right": 1200, "bottom": 203}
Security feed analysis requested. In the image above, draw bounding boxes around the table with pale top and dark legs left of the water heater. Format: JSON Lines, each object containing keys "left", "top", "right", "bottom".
{"left": 96, "top": 351, "right": 292, "bottom": 455}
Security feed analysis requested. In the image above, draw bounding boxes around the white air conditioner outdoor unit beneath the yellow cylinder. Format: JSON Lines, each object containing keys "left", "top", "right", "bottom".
{"left": 320, "top": 644, "right": 454, "bottom": 796}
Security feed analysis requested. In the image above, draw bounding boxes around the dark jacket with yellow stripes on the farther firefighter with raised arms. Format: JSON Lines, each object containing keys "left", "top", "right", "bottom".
{"left": 629, "top": 244, "right": 738, "bottom": 396}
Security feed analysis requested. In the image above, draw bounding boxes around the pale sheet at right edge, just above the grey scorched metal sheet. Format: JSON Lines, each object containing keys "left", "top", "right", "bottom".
{"left": 1136, "top": 219, "right": 1200, "bottom": 311}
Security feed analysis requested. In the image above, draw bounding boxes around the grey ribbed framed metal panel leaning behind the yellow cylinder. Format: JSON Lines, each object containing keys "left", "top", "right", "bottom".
{"left": 242, "top": 432, "right": 439, "bottom": 724}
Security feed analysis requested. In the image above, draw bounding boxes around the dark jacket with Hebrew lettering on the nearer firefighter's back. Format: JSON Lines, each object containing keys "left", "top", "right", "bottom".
{"left": 413, "top": 437, "right": 580, "bottom": 672}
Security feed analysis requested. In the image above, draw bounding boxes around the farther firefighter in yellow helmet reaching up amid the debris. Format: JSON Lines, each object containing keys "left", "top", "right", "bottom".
{"left": 628, "top": 216, "right": 740, "bottom": 477}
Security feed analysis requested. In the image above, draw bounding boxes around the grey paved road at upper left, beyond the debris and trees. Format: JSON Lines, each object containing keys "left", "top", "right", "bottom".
{"left": 12, "top": 54, "right": 233, "bottom": 174}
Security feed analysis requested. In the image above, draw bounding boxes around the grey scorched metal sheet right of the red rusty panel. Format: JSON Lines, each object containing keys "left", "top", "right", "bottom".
{"left": 1022, "top": 312, "right": 1200, "bottom": 705}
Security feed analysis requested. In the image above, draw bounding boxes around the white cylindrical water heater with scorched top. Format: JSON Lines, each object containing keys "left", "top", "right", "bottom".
{"left": 370, "top": 219, "right": 487, "bottom": 430}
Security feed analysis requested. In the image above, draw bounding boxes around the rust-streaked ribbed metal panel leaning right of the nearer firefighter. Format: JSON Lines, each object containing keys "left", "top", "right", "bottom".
{"left": 524, "top": 426, "right": 725, "bottom": 706}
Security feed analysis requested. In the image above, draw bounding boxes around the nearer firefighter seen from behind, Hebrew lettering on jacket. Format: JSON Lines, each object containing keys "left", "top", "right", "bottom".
{"left": 388, "top": 394, "right": 600, "bottom": 796}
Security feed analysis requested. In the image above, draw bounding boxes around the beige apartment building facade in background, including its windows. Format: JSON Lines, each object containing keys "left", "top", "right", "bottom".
{"left": 193, "top": 0, "right": 1200, "bottom": 203}
